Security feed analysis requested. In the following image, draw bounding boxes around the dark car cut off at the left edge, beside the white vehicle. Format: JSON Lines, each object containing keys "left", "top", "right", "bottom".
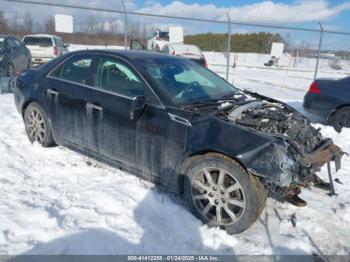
{"left": 0, "top": 35, "right": 31, "bottom": 77}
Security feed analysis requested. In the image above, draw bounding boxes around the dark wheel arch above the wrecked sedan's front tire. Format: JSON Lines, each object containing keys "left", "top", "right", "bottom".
{"left": 178, "top": 150, "right": 248, "bottom": 195}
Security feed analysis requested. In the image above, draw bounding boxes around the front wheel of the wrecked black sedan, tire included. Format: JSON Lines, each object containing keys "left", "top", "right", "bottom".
{"left": 183, "top": 153, "right": 268, "bottom": 234}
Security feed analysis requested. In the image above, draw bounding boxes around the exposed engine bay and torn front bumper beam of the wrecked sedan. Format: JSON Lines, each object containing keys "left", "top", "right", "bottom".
{"left": 223, "top": 100, "right": 344, "bottom": 174}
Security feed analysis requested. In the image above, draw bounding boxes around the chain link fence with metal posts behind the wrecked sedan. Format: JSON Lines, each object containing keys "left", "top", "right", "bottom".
{"left": 0, "top": 0, "right": 350, "bottom": 99}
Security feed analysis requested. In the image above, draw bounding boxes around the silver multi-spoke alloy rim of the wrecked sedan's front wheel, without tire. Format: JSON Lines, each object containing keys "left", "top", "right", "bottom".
{"left": 191, "top": 167, "right": 246, "bottom": 226}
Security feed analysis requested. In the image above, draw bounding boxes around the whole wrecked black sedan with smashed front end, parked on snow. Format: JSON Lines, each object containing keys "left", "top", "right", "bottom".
{"left": 14, "top": 50, "right": 342, "bottom": 234}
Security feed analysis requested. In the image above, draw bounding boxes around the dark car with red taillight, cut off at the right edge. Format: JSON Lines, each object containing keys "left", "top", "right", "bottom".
{"left": 304, "top": 77, "right": 350, "bottom": 132}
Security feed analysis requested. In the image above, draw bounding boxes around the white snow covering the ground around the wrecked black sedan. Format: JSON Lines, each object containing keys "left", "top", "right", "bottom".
{"left": 0, "top": 50, "right": 350, "bottom": 256}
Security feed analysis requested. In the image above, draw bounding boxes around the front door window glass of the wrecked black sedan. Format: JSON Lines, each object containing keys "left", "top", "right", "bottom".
{"left": 95, "top": 57, "right": 144, "bottom": 97}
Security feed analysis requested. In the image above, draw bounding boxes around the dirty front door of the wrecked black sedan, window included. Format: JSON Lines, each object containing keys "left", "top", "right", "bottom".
{"left": 86, "top": 56, "right": 188, "bottom": 180}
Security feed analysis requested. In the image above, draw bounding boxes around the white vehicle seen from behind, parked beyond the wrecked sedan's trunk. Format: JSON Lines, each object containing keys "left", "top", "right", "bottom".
{"left": 23, "top": 34, "right": 69, "bottom": 66}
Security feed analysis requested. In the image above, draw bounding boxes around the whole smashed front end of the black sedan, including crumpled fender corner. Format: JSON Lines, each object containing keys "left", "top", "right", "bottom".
{"left": 223, "top": 100, "right": 344, "bottom": 198}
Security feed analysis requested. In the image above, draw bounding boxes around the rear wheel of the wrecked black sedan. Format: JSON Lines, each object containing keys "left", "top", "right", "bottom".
{"left": 24, "top": 102, "right": 55, "bottom": 147}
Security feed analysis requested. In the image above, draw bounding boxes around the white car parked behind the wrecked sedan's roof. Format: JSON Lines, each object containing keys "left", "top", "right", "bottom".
{"left": 161, "top": 44, "right": 208, "bottom": 67}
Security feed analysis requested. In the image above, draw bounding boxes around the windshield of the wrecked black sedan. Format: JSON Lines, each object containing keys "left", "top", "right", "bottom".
{"left": 137, "top": 57, "right": 236, "bottom": 104}
